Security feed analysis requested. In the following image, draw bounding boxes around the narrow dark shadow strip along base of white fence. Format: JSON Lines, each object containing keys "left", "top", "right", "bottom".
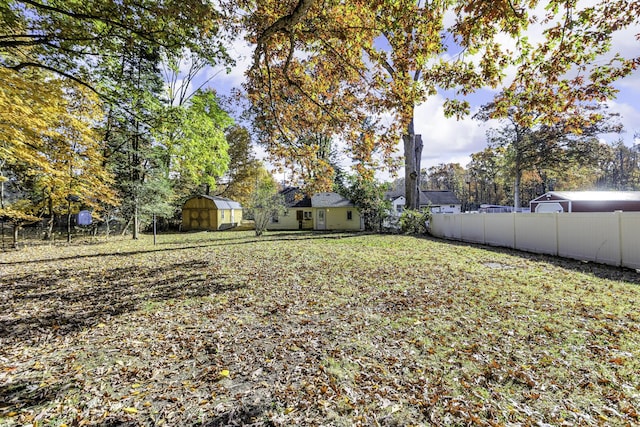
{"left": 416, "top": 236, "right": 640, "bottom": 285}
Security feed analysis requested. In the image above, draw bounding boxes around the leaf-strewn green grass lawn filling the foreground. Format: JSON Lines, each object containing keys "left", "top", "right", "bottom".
{"left": 0, "top": 232, "right": 640, "bottom": 426}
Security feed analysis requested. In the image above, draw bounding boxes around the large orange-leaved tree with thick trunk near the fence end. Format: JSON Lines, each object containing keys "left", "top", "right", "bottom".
{"left": 229, "top": 0, "right": 640, "bottom": 207}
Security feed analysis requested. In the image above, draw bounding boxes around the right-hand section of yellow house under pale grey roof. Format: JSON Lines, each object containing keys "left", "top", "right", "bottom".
{"left": 311, "top": 192, "right": 364, "bottom": 231}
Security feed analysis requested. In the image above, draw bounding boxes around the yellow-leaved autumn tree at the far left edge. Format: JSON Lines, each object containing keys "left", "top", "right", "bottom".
{"left": 0, "top": 68, "right": 118, "bottom": 241}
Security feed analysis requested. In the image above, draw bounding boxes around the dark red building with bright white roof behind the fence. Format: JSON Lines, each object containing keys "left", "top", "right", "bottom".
{"left": 529, "top": 191, "right": 640, "bottom": 213}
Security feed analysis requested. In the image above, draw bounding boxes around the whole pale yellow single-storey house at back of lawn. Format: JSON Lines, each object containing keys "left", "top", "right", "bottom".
{"left": 267, "top": 187, "right": 364, "bottom": 230}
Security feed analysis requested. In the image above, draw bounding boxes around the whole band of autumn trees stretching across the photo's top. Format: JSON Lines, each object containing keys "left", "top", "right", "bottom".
{"left": 0, "top": 0, "right": 640, "bottom": 246}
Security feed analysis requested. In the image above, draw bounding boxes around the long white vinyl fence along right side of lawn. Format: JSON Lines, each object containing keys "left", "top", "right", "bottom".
{"left": 430, "top": 212, "right": 640, "bottom": 269}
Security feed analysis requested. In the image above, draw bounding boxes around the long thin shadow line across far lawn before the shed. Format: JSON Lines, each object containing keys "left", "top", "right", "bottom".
{"left": 0, "top": 231, "right": 364, "bottom": 265}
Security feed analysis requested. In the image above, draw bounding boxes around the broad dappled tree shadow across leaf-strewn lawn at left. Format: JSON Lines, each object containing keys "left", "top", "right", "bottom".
{"left": 0, "top": 262, "right": 246, "bottom": 341}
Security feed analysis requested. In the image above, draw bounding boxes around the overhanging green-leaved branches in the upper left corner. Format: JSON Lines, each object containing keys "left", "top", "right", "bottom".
{"left": 0, "top": 0, "right": 228, "bottom": 95}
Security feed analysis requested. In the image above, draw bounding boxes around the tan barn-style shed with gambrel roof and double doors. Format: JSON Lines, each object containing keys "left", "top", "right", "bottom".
{"left": 182, "top": 195, "right": 242, "bottom": 231}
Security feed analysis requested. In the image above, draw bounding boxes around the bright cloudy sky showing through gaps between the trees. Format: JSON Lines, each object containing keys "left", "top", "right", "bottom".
{"left": 195, "top": 8, "right": 640, "bottom": 179}
